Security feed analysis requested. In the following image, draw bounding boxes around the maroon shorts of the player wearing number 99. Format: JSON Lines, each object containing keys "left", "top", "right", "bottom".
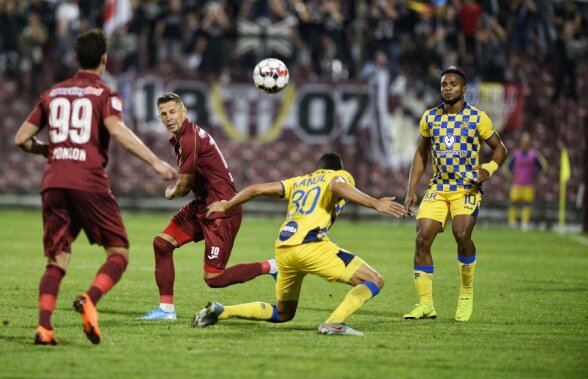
{"left": 41, "top": 188, "right": 129, "bottom": 257}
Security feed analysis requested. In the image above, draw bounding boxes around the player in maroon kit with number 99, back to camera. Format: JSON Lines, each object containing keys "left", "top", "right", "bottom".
{"left": 14, "top": 29, "right": 177, "bottom": 345}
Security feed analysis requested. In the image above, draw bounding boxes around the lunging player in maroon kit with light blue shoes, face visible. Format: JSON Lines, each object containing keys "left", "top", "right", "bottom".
{"left": 140, "top": 93, "right": 277, "bottom": 320}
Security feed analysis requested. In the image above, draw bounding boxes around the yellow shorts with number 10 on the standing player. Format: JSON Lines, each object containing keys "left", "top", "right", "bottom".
{"left": 416, "top": 189, "right": 482, "bottom": 229}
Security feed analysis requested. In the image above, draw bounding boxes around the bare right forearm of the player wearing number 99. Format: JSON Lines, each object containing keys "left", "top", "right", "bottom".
{"left": 104, "top": 116, "right": 178, "bottom": 180}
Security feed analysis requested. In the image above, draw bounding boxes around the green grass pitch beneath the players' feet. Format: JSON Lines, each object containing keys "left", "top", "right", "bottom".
{"left": 0, "top": 210, "right": 588, "bottom": 379}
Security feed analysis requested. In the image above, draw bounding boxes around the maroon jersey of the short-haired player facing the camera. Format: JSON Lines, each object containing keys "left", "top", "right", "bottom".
{"left": 170, "top": 119, "right": 241, "bottom": 218}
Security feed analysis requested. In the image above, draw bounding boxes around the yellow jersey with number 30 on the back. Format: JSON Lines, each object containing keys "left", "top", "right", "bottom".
{"left": 275, "top": 170, "right": 355, "bottom": 247}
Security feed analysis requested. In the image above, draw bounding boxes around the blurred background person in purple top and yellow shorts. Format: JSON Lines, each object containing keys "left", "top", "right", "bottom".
{"left": 504, "top": 132, "right": 547, "bottom": 231}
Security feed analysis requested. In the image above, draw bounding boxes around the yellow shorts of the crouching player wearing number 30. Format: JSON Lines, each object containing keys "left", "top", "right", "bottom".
{"left": 276, "top": 241, "right": 365, "bottom": 301}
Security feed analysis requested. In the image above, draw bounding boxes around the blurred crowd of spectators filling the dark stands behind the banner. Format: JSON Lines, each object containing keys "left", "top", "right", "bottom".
{"left": 0, "top": 0, "right": 588, "bottom": 226}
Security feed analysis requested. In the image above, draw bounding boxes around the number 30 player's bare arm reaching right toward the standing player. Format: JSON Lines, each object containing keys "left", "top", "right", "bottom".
{"left": 330, "top": 180, "right": 405, "bottom": 218}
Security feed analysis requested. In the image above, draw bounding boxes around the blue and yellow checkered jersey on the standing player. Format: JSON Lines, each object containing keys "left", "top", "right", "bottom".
{"left": 419, "top": 103, "right": 496, "bottom": 192}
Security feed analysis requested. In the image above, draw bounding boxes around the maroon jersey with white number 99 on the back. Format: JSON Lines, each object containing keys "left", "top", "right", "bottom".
{"left": 27, "top": 72, "right": 122, "bottom": 192}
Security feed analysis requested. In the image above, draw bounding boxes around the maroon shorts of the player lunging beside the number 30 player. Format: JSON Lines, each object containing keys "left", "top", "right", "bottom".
{"left": 163, "top": 201, "right": 243, "bottom": 272}
